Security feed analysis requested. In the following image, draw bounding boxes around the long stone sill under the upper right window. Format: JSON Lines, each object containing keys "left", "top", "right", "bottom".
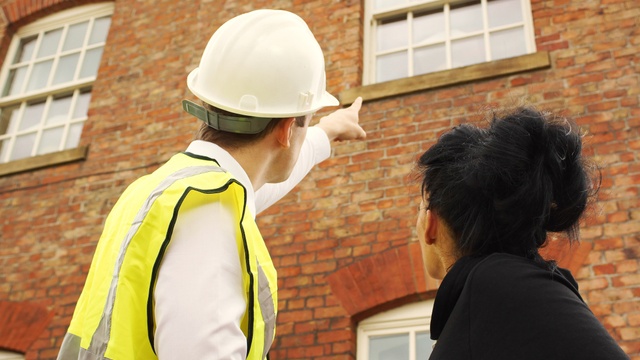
{"left": 339, "top": 51, "right": 551, "bottom": 105}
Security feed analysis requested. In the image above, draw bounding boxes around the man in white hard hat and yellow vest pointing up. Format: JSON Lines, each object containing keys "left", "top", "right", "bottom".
{"left": 58, "top": 10, "right": 365, "bottom": 360}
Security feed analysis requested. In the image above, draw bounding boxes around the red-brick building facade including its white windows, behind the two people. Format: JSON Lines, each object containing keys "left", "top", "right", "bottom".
{"left": 0, "top": 0, "right": 640, "bottom": 360}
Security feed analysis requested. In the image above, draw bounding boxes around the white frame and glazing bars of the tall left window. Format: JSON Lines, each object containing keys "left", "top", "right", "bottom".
{"left": 0, "top": 2, "right": 114, "bottom": 164}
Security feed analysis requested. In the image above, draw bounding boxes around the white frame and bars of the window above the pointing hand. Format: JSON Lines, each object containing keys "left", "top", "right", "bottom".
{"left": 362, "top": 0, "right": 536, "bottom": 85}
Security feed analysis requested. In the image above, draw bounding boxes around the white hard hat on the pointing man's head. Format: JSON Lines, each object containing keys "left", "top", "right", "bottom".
{"left": 187, "top": 10, "right": 339, "bottom": 118}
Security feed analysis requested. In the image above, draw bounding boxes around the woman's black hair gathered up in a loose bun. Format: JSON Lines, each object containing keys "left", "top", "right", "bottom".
{"left": 418, "top": 107, "right": 597, "bottom": 266}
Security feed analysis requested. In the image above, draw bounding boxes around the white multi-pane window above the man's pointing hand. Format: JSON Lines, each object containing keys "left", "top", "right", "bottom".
{"left": 363, "top": 0, "right": 536, "bottom": 84}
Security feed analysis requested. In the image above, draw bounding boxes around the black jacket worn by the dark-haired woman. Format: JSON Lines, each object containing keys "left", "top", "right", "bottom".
{"left": 429, "top": 254, "right": 629, "bottom": 360}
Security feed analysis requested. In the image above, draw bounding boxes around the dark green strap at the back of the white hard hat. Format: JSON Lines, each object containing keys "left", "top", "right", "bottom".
{"left": 182, "top": 100, "right": 273, "bottom": 134}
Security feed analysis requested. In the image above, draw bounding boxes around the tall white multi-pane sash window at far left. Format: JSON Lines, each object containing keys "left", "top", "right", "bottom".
{"left": 0, "top": 3, "right": 113, "bottom": 163}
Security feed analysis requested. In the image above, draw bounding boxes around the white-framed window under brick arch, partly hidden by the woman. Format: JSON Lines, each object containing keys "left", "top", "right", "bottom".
{"left": 357, "top": 300, "right": 433, "bottom": 360}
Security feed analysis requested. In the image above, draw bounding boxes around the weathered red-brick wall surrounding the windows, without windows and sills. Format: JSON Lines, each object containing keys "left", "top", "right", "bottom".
{"left": 0, "top": 0, "right": 640, "bottom": 360}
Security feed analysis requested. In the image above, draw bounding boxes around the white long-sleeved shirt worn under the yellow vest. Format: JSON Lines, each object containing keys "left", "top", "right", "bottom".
{"left": 154, "top": 127, "right": 331, "bottom": 360}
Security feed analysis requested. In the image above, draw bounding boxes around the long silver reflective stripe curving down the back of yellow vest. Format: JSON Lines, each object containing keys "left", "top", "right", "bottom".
{"left": 88, "top": 166, "right": 224, "bottom": 358}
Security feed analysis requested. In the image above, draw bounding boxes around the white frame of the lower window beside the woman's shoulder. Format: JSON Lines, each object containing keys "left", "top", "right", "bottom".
{"left": 356, "top": 300, "right": 433, "bottom": 360}
